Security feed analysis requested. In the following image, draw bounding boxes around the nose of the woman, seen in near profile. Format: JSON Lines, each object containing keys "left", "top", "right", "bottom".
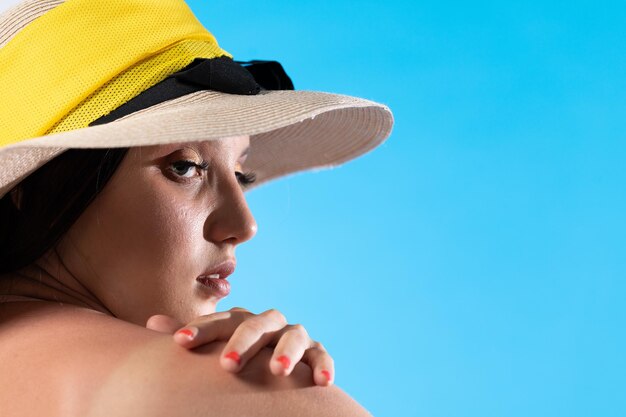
{"left": 206, "top": 171, "right": 258, "bottom": 245}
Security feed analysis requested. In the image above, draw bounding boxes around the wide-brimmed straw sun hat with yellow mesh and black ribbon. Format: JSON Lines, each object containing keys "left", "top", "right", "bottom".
{"left": 0, "top": 0, "right": 393, "bottom": 197}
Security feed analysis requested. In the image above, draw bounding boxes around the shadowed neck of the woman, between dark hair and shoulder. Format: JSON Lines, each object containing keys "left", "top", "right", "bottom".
{"left": 0, "top": 244, "right": 115, "bottom": 316}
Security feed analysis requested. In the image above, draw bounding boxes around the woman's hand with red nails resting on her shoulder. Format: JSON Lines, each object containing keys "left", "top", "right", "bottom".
{"left": 146, "top": 307, "right": 335, "bottom": 386}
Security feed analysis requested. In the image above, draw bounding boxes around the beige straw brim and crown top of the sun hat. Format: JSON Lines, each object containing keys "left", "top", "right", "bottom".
{"left": 0, "top": 0, "right": 393, "bottom": 197}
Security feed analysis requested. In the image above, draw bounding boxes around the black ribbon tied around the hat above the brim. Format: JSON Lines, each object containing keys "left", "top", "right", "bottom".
{"left": 89, "top": 56, "right": 294, "bottom": 126}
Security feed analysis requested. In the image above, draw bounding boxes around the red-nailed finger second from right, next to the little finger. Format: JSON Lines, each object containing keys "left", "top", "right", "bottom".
{"left": 270, "top": 324, "right": 313, "bottom": 375}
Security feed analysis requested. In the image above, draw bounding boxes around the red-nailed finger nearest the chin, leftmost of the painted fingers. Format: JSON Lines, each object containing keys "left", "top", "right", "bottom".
{"left": 174, "top": 311, "right": 246, "bottom": 349}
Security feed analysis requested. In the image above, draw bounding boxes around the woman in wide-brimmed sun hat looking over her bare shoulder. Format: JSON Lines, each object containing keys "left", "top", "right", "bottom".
{"left": 0, "top": 0, "right": 392, "bottom": 416}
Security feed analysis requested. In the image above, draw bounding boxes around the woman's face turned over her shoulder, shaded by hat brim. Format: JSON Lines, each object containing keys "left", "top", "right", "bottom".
{"left": 57, "top": 136, "right": 257, "bottom": 325}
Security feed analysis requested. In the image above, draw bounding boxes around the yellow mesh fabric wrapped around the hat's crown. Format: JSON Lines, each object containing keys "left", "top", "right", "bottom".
{"left": 0, "top": 0, "right": 232, "bottom": 146}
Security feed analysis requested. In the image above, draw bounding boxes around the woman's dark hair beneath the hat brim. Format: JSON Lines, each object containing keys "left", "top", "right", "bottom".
{"left": 0, "top": 148, "right": 128, "bottom": 273}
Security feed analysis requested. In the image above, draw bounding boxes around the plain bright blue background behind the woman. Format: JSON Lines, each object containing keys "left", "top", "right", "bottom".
{"left": 188, "top": 0, "right": 626, "bottom": 417}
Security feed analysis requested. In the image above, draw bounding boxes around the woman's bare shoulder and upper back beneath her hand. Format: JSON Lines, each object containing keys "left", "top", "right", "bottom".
{"left": 0, "top": 302, "right": 370, "bottom": 417}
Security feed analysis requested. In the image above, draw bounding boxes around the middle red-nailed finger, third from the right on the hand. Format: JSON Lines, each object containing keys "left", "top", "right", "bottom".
{"left": 220, "top": 309, "right": 287, "bottom": 372}
